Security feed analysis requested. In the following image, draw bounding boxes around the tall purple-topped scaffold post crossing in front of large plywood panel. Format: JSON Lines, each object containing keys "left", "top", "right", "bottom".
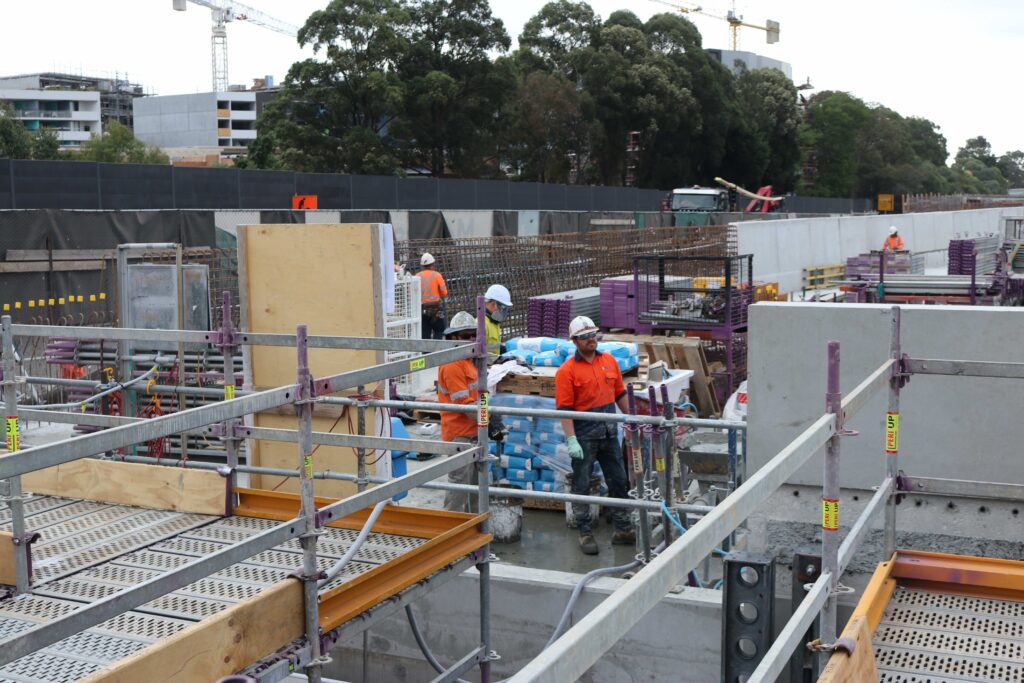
{"left": 295, "top": 325, "right": 324, "bottom": 683}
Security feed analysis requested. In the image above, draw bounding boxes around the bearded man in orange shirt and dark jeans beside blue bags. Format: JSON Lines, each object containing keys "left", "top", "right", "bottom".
{"left": 555, "top": 315, "right": 636, "bottom": 555}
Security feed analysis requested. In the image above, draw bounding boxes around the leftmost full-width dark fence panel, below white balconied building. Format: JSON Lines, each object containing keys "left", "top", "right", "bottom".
{"left": 11, "top": 160, "right": 99, "bottom": 209}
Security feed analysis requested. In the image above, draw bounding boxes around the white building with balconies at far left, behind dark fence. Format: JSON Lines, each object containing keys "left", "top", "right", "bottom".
{"left": 0, "top": 89, "right": 103, "bottom": 148}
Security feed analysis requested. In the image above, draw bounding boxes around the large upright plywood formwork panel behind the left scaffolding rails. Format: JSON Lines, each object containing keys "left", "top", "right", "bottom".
{"left": 239, "top": 223, "right": 386, "bottom": 498}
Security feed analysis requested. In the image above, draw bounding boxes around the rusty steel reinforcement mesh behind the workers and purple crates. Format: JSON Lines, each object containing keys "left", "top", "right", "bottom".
{"left": 395, "top": 225, "right": 736, "bottom": 337}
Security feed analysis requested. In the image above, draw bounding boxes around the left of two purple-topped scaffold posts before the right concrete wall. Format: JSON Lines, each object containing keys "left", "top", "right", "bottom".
{"left": 820, "top": 341, "right": 843, "bottom": 657}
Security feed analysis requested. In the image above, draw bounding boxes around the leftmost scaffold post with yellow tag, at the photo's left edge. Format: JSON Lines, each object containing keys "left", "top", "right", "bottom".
{"left": 0, "top": 315, "right": 32, "bottom": 593}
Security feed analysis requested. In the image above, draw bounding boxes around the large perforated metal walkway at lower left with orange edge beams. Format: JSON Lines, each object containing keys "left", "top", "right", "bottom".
{"left": 0, "top": 497, "right": 425, "bottom": 683}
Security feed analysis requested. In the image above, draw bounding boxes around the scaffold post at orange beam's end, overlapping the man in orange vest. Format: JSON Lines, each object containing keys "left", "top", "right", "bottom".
{"left": 475, "top": 296, "right": 492, "bottom": 683}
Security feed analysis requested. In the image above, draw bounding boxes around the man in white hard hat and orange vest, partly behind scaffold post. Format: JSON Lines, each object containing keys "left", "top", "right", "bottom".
{"left": 437, "top": 310, "right": 506, "bottom": 512}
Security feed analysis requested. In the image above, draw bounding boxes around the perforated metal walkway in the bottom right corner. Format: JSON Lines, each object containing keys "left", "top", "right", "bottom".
{"left": 872, "top": 586, "right": 1024, "bottom": 683}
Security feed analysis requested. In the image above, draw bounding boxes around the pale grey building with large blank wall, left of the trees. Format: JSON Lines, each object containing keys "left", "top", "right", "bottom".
{"left": 133, "top": 90, "right": 256, "bottom": 153}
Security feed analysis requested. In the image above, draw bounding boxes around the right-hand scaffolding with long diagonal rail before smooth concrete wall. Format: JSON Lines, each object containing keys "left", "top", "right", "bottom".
{"left": 510, "top": 306, "right": 1024, "bottom": 683}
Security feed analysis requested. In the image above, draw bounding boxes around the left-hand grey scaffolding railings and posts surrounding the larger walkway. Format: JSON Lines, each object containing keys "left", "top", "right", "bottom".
{"left": 0, "top": 293, "right": 745, "bottom": 682}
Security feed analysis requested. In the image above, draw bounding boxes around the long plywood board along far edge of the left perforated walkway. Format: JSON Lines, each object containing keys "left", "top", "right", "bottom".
{"left": 22, "top": 458, "right": 227, "bottom": 515}
